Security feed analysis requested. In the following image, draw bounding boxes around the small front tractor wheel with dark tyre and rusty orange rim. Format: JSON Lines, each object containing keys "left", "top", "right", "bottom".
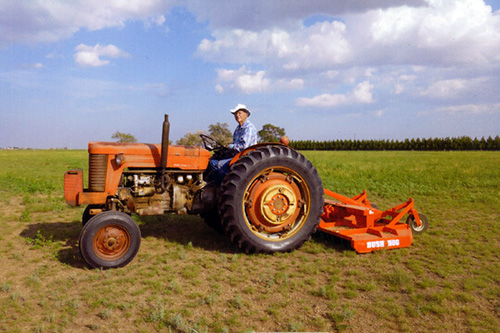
{"left": 79, "top": 211, "right": 141, "bottom": 269}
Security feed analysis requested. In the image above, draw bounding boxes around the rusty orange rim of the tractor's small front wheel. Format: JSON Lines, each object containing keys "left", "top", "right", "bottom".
{"left": 92, "top": 224, "right": 131, "bottom": 261}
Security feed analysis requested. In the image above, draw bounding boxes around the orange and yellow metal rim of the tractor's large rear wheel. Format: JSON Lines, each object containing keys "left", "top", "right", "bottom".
{"left": 242, "top": 167, "right": 311, "bottom": 241}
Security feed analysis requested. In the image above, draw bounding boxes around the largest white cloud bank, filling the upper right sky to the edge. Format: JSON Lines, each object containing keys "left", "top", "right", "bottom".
{"left": 197, "top": 0, "right": 500, "bottom": 73}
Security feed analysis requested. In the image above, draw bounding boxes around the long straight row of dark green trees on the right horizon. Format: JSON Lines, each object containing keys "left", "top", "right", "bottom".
{"left": 290, "top": 135, "right": 500, "bottom": 151}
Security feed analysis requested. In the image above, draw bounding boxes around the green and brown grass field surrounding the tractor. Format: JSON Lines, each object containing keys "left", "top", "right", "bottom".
{"left": 0, "top": 150, "right": 500, "bottom": 332}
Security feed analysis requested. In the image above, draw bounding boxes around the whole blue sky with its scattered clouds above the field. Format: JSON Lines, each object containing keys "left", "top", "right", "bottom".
{"left": 0, "top": 0, "right": 500, "bottom": 149}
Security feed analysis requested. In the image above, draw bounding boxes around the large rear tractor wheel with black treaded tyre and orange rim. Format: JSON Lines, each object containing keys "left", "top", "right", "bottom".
{"left": 220, "top": 145, "right": 324, "bottom": 253}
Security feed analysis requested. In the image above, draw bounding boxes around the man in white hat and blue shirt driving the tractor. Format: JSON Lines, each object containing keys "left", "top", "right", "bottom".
{"left": 210, "top": 104, "right": 257, "bottom": 184}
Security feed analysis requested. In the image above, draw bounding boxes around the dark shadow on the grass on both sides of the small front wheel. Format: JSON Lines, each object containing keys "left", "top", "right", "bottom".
{"left": 20, "top": 214, "right": 239, "bottom": 268}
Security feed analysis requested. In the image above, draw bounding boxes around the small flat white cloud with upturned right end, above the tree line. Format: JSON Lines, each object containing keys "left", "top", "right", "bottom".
{"left": 295, "top": 81, "right": 373, "bottom": 108}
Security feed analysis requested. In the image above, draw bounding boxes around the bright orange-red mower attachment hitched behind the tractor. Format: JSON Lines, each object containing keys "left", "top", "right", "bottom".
{"left": 318, "top": 189, "right": 424, "bottom": 253}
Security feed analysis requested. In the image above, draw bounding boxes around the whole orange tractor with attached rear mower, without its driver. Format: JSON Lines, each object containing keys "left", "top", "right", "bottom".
{"left": 64, "top": 115, "right": 427, "bottom": 268}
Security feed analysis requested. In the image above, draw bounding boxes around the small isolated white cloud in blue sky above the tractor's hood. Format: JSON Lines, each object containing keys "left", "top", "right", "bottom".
{"left": 74, "top": 44, "right": 130, "bottom": 67}
